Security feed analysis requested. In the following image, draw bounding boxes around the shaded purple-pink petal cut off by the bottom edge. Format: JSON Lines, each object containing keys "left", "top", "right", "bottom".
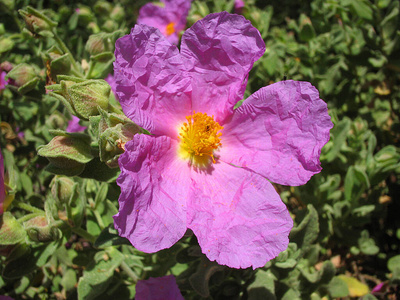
{"left": 135, "top": 275, "right": 184, "bottom": 300}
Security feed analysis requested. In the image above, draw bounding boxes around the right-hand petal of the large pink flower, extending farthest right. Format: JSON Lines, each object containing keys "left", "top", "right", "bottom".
{"left": 220, "top": 80, "right": 333, "bottom": 186}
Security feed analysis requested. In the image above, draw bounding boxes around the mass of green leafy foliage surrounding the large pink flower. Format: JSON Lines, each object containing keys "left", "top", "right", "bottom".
{"left": 0, "top": 0, "right": 400, "bottom": 300}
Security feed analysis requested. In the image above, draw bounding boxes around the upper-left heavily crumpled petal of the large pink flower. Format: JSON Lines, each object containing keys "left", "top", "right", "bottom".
{"left": 114, "top": 25, "right": 191, "bottom": 137}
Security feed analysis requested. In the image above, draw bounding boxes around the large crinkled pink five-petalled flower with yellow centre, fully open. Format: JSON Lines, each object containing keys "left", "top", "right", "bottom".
{"left": 114, "top": 12, "right": 332, "bottom": 268}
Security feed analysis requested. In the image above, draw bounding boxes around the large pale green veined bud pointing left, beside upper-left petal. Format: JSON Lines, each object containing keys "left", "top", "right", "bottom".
{"left": 48, "top": 76, "right": 111, "bottom": 120}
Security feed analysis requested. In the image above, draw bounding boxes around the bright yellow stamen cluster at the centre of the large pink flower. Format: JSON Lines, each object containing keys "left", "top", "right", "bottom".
{"left": 178, "top": 112, "right": 223, "bottom": 166}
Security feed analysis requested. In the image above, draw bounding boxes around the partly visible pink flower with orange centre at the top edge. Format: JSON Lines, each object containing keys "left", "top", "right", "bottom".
{"left": 137, "top": 0, "right": 191, "bottom": 44}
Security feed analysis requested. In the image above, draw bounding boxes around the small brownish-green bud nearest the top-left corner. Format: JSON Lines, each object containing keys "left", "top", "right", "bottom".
{"left": 18, "top": 6, "right": 57, "bottom": 37}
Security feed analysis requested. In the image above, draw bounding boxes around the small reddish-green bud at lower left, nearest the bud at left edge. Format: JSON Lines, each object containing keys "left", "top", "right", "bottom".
{"left": 24, "top": 216, "right": 61, "bottom": 242}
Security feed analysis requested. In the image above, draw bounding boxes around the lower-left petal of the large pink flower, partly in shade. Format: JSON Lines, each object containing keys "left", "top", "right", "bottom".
{"left": 114, "top": 134, "right": 190, "bottom": 252}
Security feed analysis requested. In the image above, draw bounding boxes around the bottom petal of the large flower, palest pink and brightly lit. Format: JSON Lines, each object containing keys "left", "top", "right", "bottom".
{"left": 187, "top": 162, "right": 293, "bottom": 269}
